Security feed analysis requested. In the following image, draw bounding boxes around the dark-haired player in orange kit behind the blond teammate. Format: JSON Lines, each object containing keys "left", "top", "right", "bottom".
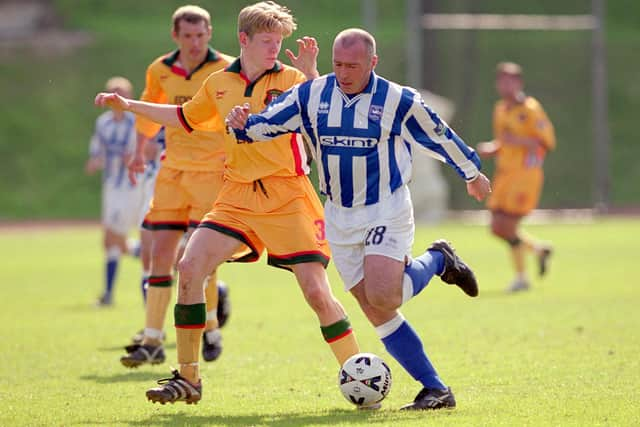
{"left": 120, "top": 6, "right": 233, "bottom": 367}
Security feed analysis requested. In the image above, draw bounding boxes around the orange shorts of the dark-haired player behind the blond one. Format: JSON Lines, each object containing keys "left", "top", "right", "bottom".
{"left": 143, "top": 167, "right": 224, "bottom": 231}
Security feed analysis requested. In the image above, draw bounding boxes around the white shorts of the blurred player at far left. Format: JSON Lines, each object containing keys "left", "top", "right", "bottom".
{"left": 102, "top": 185, "right": 148, "bottom": 236}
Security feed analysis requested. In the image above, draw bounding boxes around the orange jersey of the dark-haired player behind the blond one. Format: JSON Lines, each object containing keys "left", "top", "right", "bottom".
{"left": 136, "top": 48, "right": 233, "bottom": 171}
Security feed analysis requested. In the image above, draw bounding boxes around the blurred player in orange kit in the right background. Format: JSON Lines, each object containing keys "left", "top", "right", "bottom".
{"left": 477, "top": 62, "right": 556, "bottom": 292}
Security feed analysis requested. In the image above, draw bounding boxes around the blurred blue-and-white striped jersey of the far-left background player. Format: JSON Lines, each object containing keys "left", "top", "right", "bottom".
{"left": 89, "top": 111, "right": 136, "bottom": 188}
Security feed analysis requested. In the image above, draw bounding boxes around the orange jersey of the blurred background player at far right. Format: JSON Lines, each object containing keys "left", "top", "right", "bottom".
{"left": 493, "top": 96, "right": 556, "bottom": 172}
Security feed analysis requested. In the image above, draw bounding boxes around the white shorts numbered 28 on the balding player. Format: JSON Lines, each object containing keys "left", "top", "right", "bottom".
{"left": 324, "top": 186, "right": 415, "bottom": 291}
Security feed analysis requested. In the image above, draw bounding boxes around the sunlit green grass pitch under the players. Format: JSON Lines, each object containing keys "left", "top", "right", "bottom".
{"left": 0, "top": 219, "right": 640, "bottom": 427}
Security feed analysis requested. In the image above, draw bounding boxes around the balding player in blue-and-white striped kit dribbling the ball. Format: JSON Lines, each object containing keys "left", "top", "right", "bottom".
{"left": 227, "top": 29, "right": 491, "bottom": 409}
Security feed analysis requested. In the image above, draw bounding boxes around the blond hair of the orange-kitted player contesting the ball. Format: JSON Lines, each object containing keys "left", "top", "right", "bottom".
{"left": 238, "top": 1, "right": 298, "bottom": 37}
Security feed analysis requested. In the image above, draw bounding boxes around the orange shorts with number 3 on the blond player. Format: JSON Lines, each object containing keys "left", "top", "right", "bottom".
{"left": 200, "top": 176, "right": 331, "bottom": 270}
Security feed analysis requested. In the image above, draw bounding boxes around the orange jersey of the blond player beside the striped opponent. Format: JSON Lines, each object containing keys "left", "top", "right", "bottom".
{"left": 178, "top": 59, "right": 309, "bottom": 183}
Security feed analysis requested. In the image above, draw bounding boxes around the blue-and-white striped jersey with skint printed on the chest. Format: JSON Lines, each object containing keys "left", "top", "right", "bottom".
{"left": 234, "top": 72, "right": 480, "bottom": 207}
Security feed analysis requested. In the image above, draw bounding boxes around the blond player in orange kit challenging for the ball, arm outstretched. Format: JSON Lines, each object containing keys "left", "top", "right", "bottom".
{"left": 95, "top": 1, "right": 359, "bottom": 403}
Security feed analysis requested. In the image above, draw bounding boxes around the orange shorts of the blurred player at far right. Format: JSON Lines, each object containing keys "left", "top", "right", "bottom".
{"left": 487, "top": 169, "right": 544, "bottom": 216}
